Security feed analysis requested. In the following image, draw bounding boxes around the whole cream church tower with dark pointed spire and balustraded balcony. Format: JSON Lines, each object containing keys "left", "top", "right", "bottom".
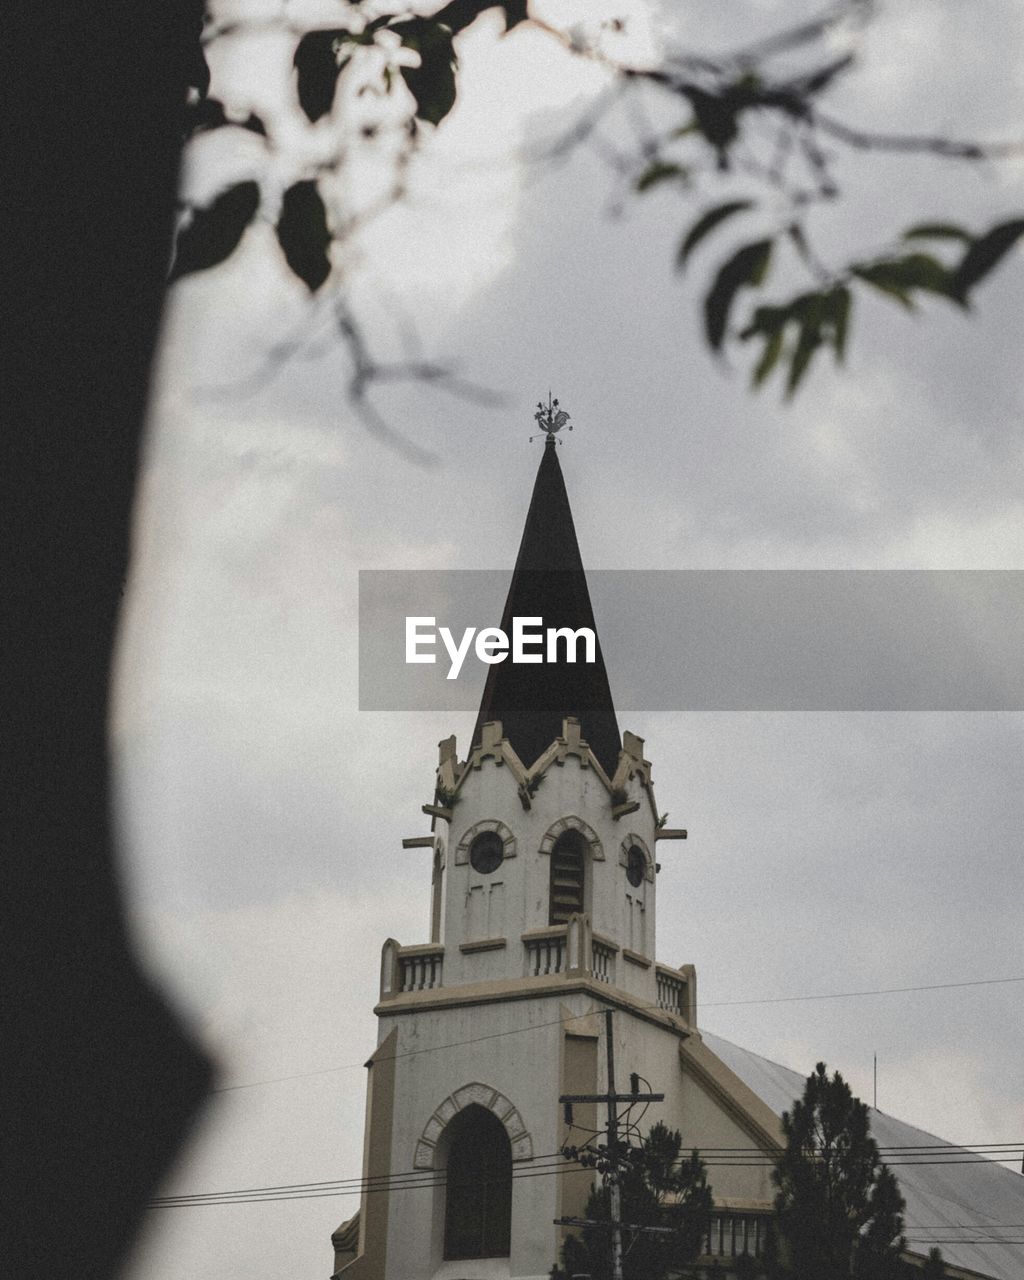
{"left": 333, "top": 417, "right": 711, "bottom": 1280}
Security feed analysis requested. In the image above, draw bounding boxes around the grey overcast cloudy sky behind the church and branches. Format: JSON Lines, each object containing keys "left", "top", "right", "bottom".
{"left": 114, "top": 0, "right": 1024, "bottom": 1280}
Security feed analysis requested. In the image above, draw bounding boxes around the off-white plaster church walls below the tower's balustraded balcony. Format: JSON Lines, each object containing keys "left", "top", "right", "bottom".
{"left": 381, "top": 993, "right": 772, "bottom": 1280}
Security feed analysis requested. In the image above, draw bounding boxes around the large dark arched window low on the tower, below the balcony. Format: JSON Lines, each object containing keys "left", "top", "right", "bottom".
{"left": 444, "top": 1105, "right": 512, "bottom": 1258}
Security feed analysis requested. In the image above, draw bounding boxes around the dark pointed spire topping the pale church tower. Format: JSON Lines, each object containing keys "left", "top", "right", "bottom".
{"left": 472, "top": 435, "right": 622, "bottom": 777}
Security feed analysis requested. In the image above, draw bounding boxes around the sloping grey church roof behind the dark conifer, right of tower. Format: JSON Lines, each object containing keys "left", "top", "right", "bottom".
{"left": 701, "top": 1032, "right": 1024, "bottom": 1280}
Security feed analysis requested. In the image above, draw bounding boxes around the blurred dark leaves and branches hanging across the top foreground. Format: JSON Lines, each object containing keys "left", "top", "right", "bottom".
{"left": 172, "top": 0, "right": 1024, "bottom": 397}
